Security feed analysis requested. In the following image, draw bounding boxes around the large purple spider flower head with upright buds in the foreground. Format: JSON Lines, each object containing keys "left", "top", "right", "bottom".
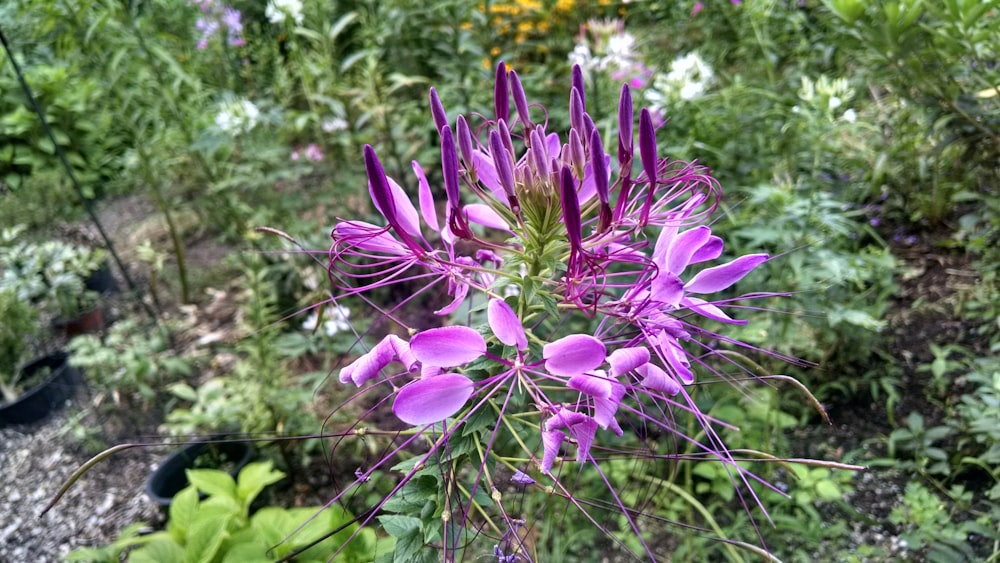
{"left": 320, "top": 63, "right": 780, "bottom": 560}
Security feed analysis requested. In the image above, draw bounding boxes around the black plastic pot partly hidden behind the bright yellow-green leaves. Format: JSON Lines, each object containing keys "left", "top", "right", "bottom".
{"left": 146, "top": 442, "right": 254, "bottom": 508}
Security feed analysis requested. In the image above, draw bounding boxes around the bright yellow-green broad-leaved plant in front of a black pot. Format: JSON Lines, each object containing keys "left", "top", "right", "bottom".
{"left": 66, "top": 462, "right": 376, "bottom": 563}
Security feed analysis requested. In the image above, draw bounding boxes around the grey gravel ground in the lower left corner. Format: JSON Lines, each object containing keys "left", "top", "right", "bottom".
{"left": 0, "top": 409, "right": 161, "bottom": 563}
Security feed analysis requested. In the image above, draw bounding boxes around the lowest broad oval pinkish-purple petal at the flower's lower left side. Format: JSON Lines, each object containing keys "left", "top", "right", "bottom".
{"left": 392, "top": 373, "right": 475, "bottom": 426}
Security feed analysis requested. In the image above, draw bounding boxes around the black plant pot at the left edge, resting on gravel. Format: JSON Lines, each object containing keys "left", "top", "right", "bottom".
{"left": 0, "top": 352, "right": 82, "bottom": 426}
